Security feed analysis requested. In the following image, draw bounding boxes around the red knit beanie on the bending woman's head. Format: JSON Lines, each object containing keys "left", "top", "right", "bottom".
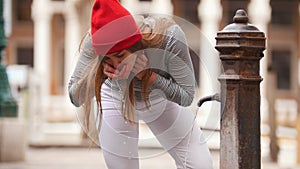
{"left": 91, "top": 0, "right": 142, "bottom": 55}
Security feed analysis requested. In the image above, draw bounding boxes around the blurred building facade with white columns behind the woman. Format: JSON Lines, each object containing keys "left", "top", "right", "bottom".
{"left": 5, "top": 0, "right": 300, "bottom": 162}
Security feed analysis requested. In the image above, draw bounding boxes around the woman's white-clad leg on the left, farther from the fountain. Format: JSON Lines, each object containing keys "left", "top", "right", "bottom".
{"left": 99, "top": 84, "right": 139, "bottom": 169}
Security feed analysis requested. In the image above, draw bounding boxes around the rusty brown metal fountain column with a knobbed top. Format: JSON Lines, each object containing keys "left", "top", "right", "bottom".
{"left": 216, "top": 10, "right": 265, "bottom": 169}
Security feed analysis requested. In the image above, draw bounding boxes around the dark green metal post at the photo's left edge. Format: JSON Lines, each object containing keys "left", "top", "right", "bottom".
{"left": 0, "top": 0, "right": 17, "bottom": 117}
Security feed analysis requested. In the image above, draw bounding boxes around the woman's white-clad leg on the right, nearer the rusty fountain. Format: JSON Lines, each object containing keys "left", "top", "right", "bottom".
{"left": 139, "top": 100, "right": 213, "bottom": 169}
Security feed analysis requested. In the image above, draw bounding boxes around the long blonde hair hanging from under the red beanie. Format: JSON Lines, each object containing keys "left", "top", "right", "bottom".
{"left": 79, "top": 18, "right": 175, "bottom": 132}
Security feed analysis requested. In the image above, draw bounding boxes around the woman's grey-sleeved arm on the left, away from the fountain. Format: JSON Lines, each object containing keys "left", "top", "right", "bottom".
{"left": 68, "top": 32, "right": 97, "bottom": 107}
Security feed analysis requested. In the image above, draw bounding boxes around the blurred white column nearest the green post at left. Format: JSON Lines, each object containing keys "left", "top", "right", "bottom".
{"left": 29, "top": 0, "right": 51, "bottom": 141}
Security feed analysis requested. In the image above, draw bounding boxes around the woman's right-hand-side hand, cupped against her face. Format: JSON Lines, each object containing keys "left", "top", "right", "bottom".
{"left": 132, "top": 53, "right": 148, "bottom": 79}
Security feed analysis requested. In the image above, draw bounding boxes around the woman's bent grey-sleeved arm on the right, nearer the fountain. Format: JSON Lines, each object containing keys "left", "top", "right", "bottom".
{"left": 152, "top": 25, "right": 195, "bottom": 106}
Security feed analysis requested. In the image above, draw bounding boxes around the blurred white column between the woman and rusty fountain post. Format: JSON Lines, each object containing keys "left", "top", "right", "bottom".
{"left": 198, "top": 0, "right": 222, "bottom": 95}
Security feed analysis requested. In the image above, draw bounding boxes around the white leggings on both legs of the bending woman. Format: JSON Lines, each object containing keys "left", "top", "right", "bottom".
{"left": 99, "top": 84, "right": 213, "bottom": 169}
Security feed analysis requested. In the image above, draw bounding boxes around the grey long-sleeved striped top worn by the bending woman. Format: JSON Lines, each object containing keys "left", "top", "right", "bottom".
{"left": 68, "top": 20, "right": 195, "bottom": 107}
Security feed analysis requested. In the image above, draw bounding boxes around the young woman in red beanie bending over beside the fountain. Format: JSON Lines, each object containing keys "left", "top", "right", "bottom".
{"left": 69, "top": 0, "right": 212, "bottom": 169}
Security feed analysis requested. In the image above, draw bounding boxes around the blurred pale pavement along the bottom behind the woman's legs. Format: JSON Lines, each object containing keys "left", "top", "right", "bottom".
{"left": 0, "top": 147, "right": 300, "bottom": 169}
